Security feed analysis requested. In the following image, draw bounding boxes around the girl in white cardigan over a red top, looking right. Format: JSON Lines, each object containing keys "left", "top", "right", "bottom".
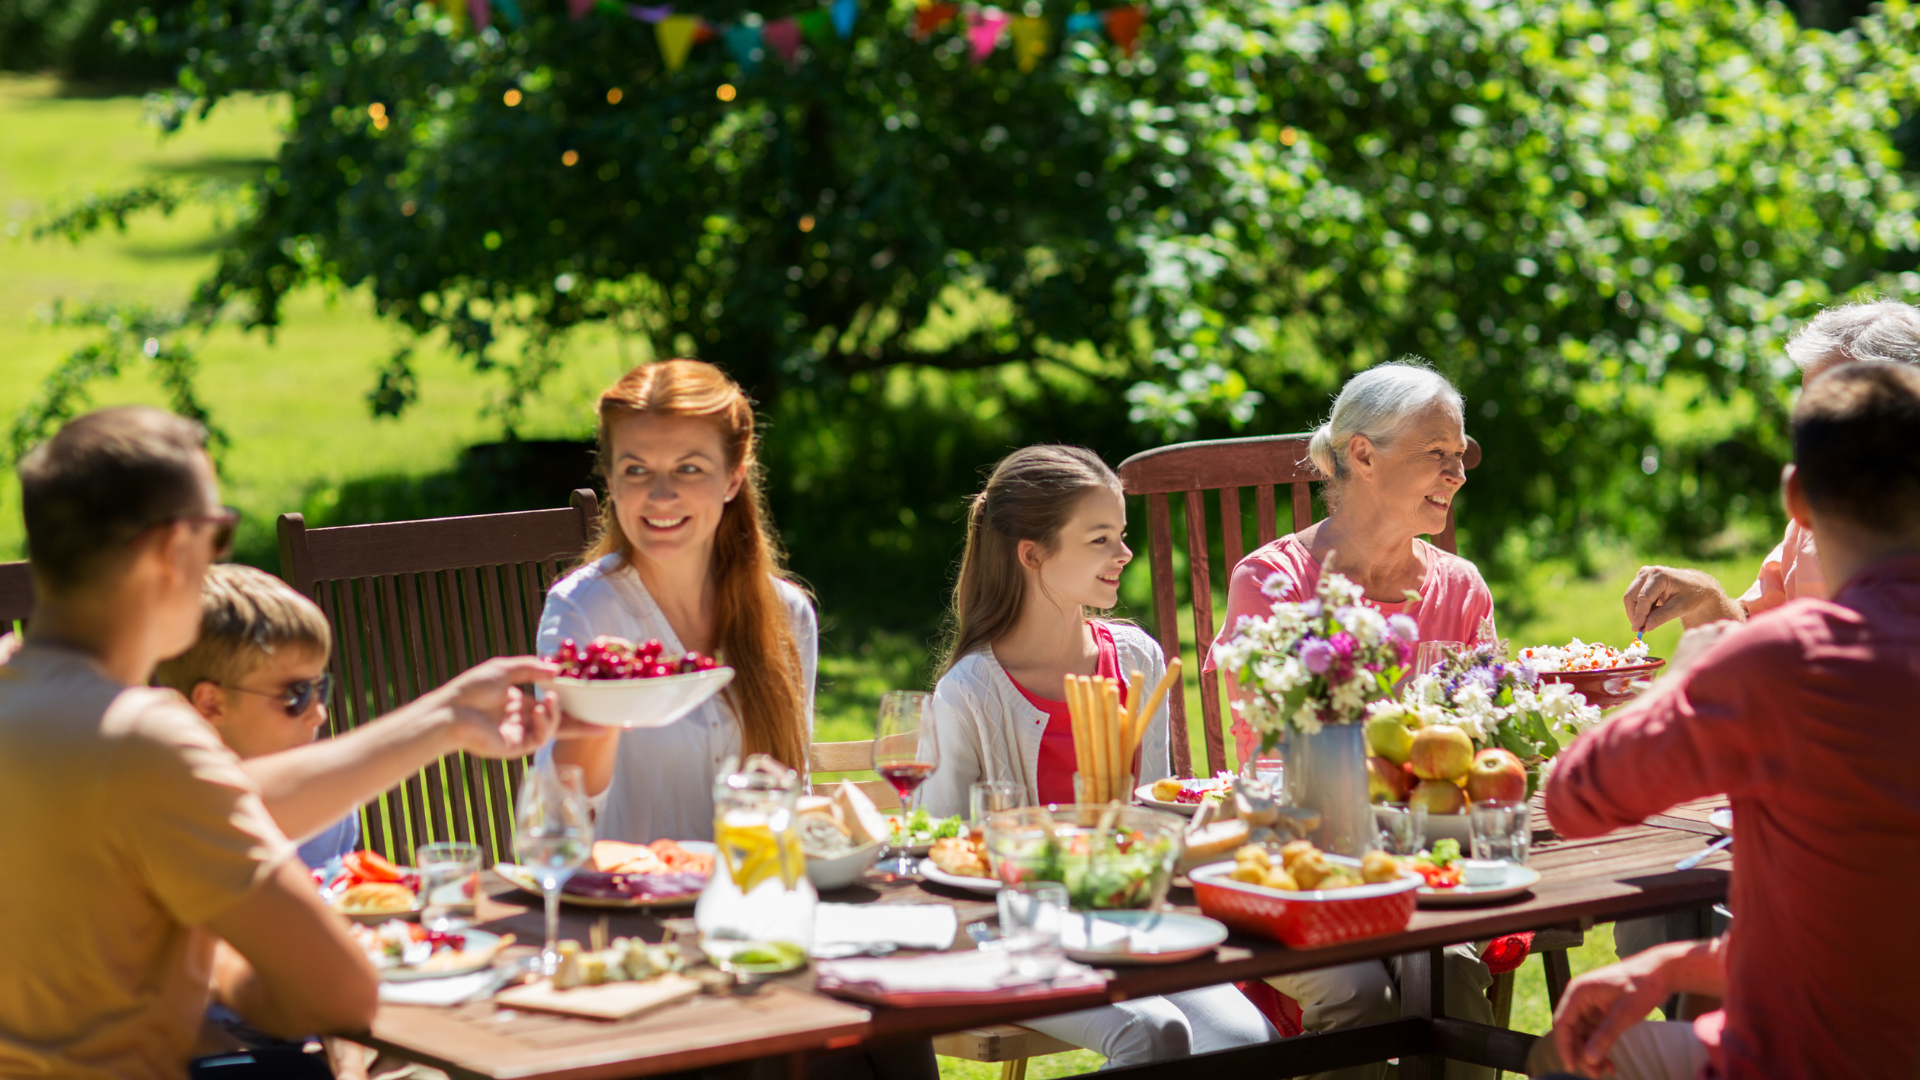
{"left": 925, "top": 446, "right": 1279, "bottom": 1067}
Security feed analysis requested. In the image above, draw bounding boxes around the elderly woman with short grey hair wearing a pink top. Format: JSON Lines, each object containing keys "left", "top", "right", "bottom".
{"left": 1206, "top": 363, "right": 1494, "bottom": 1080}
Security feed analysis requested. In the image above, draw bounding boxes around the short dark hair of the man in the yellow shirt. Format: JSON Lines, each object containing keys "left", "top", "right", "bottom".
{"left": 19, "top": 405, "right": 207, "bottom": 592}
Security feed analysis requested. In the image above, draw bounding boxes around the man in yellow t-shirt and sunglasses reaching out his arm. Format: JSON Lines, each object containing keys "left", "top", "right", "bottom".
{"left": 0, "top": 407, "right": 555, "bottom": 1080}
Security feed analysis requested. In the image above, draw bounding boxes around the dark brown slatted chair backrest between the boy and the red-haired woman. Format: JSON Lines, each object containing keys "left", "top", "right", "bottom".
{"left": 280, "top": 488, "right": 599, "bottom": 865}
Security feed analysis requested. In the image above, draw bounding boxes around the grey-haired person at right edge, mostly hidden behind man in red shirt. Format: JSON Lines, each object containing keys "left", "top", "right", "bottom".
{"left": 1620, "top": 300, "right": 1920, "bottom": 632}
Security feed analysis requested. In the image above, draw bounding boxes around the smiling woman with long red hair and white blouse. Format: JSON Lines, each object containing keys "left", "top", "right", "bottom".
{"left": 540, "top": 359, "right": 820, "bottom": 844}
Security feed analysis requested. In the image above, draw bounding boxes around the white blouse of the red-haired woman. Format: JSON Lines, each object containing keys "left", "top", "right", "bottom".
{"left": 540, "top": 555, "right": 820, "bottom": 844}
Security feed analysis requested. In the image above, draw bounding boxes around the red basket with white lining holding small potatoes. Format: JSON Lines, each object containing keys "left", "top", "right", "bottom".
{"left": 1187, "top": 855, "right": 1423, "bottom": 949}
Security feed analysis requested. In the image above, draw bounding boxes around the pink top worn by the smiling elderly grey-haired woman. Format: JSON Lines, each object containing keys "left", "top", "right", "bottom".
{"left": 1204, "top": 534, "right": 1494, "bottom": 761}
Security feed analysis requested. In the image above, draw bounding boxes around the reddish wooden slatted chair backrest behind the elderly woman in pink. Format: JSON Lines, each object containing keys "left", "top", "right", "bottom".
{"left": 1119, "top": 434, "right": 1480, "bottom": 776}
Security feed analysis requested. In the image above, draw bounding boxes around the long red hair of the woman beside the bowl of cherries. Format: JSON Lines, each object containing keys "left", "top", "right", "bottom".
{"left": 586, "top": 359, "right": 806, "bottom": 773}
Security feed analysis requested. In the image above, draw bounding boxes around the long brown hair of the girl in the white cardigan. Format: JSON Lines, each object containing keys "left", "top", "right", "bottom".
{"left": 941, "top": 446, "right": 1119, "bottom": 675}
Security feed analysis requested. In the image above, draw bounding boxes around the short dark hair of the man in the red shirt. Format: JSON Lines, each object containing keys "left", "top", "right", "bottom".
{"left": 1793, "top": 363, "right": 1920, "bottom": 534}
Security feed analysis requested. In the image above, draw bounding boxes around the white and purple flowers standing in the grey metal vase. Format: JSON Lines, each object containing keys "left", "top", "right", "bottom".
{"left": 1217, "top": 573, "right": 1419, "bottom": 749}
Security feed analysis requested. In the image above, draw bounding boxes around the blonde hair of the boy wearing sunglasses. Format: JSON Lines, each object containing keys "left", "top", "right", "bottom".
{"left": 154, "top": 563, "right": 332, "bottom": 694}
